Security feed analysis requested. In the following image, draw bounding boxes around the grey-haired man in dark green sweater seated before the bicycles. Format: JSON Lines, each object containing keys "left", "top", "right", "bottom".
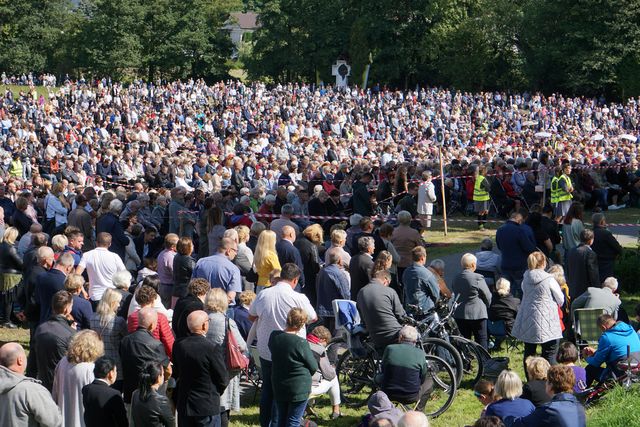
{"left": 380, "top": 325, "right": 433, "bottom": 410}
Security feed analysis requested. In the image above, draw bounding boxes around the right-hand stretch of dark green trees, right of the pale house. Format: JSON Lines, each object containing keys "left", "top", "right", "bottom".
{"left": 245, "top": 0, "right": 640, "bottom": 97}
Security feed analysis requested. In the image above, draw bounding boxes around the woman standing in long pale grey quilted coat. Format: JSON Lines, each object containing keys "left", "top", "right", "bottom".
{"left": 511, "top": 251, "right": 564, "bottom": 372}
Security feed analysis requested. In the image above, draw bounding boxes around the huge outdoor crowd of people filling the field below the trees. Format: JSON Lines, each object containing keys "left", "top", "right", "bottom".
{"left": 0, "top": 76, "right": 640, "bottom": 427}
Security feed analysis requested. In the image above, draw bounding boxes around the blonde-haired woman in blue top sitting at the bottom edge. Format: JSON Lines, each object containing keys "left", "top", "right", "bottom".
{"left": 484, "top": 370, "right": 536, "bottom": 422}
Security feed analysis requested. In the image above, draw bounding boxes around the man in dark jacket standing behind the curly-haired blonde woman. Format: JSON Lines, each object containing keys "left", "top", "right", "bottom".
{"left": 29, "top": 290, "right": 76, "bottom": 391}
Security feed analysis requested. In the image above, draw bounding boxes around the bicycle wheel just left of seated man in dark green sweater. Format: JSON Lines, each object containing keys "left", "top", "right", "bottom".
{"left": 336, "top": 350, "right": 377, "bottom": 407}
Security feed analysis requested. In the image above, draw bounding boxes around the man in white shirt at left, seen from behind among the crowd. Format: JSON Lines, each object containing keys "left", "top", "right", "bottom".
{"left": 76, "top": 233, "right": 127, "bottom": 307}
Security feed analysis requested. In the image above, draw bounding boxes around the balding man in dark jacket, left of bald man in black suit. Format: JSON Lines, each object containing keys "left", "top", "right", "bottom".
{"left": 120, "top": 307, "right": 170, "bottom": 404}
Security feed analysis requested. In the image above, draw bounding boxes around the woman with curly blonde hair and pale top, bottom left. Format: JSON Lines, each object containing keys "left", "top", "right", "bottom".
{"left": 51, "top": 329, "right": 104, "bottom": 427}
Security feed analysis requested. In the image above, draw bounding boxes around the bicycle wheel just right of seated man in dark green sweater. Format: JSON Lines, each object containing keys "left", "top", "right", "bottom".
{"left": 417, "top": 355, "right": 458, "bottom": 418}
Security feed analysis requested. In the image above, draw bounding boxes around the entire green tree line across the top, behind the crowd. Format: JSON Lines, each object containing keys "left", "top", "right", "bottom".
{"left": 0, "top": 0, "right": 640, "bottom": 98}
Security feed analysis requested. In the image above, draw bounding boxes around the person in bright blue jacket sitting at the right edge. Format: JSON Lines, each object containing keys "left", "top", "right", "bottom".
{"left": 582, "top": 314, "right": 640, "bottom": 387}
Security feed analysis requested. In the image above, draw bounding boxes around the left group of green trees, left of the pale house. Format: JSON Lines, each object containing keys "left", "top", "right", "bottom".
{"left": 0, "top": 0, "right": 242, "bottom": 79}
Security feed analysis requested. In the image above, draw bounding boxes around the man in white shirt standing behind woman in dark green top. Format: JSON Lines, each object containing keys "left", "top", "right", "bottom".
{"left": 249, "top": 263, "right": 318, "bottom": 427}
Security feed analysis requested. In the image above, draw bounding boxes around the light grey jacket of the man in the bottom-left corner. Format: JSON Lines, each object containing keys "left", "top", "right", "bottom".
{"left": 0, "top": 366, "right": 62, "bottom": 427}
